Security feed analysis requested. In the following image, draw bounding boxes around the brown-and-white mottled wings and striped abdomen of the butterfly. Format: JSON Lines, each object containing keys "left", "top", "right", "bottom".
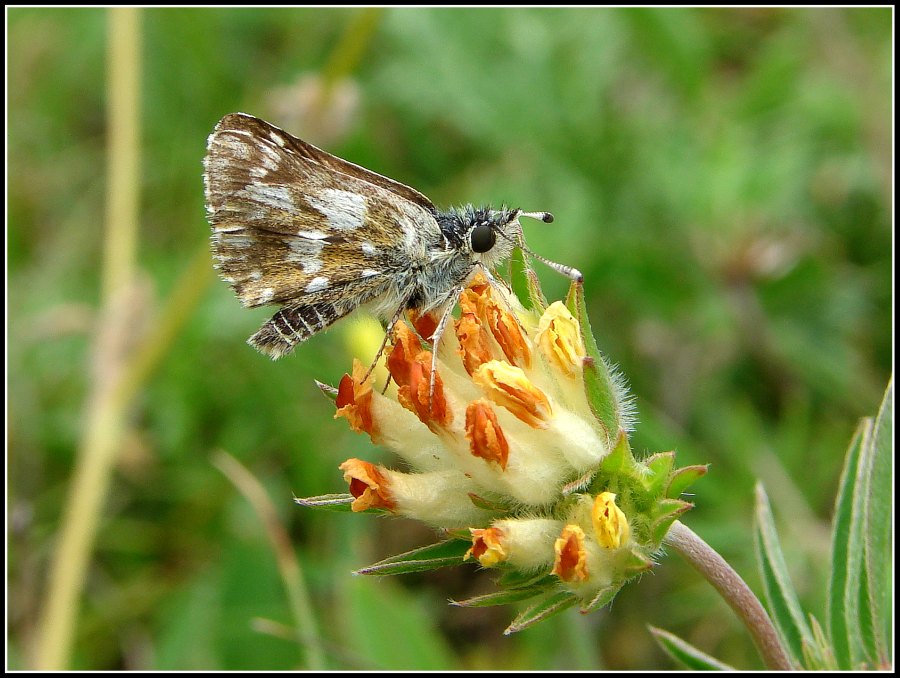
{"left": 204, "top": 113, "right": 440, "bottom": 357}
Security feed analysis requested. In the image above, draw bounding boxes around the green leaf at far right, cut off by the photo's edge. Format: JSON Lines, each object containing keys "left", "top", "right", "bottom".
{"left": 865, "top": 379, "right": 894, "bottom": 667}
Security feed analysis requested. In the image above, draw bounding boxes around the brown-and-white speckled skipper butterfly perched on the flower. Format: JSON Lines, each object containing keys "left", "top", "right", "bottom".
{"left": 203, "top": 113, "right": 582, "bottom": 374}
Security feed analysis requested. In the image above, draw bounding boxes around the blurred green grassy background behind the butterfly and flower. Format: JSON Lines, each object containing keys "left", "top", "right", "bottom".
{"left": 7, "top": 8, "right": 893, "bottom": 669}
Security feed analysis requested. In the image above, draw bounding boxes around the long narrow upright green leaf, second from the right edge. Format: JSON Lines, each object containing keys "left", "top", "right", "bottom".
{"left": 827, "top": 419, "right": 872, "bottom": 670}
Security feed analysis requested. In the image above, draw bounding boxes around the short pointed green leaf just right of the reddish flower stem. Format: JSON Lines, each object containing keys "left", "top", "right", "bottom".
{"left": 753, "top": 483, "right": 814, "bottom": 665}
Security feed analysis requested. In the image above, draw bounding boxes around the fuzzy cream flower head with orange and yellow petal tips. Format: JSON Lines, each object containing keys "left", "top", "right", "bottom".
{"left": 300, "top": 262, "right": 705, "bottom": 628}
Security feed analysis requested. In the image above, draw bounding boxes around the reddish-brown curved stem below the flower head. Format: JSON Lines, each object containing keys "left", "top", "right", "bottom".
{"left": 665, "top": 520, "right": 794, "bottom": 671}
